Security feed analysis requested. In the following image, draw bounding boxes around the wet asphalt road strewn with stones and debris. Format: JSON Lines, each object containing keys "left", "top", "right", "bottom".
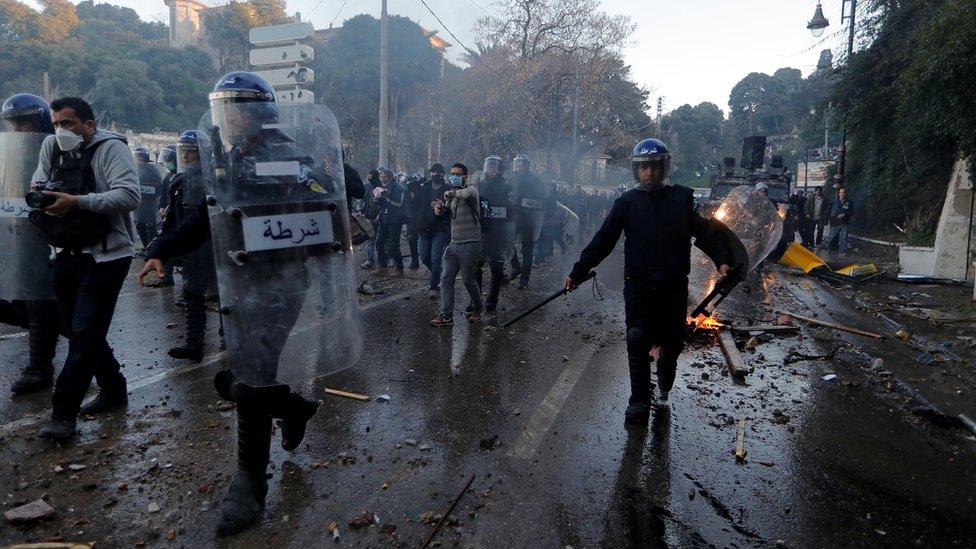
{"left": 0, "top": 241, "right": 976, "bottom": 548}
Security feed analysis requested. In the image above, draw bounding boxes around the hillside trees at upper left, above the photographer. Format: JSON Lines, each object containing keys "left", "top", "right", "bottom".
{"left": 0, "top": 0, "right": 218, "bottom": 131}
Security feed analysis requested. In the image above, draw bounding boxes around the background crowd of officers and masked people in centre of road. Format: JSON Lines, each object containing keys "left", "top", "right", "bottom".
{"left": 355, "top": 155, "right": 619, "bottom": 326}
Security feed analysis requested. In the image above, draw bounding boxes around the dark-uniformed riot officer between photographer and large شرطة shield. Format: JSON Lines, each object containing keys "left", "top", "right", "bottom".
{"left": 146, "top": 130, "right": 217, "bottom": 362}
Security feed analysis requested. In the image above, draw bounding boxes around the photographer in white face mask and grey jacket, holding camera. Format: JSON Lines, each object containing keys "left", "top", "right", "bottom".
{"left": 25, "top": 97, "right": 141, "bottom": 440}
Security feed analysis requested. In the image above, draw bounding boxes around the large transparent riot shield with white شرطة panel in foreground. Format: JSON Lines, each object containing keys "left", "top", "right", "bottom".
{"left": 199, "top": 103, "right": 362, "bottom": 386}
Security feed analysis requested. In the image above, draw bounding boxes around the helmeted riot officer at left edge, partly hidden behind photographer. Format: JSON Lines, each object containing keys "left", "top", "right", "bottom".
{"left": 0, "top": 93, "right": 64, "bottom": 395}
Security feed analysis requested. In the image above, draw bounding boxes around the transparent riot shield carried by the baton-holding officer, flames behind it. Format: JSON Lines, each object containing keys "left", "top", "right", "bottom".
{"left": 688, "top": 185, "right": 783, "bottom": 304}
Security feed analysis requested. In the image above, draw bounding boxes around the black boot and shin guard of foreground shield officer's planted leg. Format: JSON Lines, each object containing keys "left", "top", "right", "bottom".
{"left": 217, "top": 408, "right": 271, "bottom": 536}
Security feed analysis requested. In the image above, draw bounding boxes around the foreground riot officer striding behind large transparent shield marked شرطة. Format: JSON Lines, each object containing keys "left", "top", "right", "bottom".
{"left": 139, "top": 72, "right": 358, "bottom": 535}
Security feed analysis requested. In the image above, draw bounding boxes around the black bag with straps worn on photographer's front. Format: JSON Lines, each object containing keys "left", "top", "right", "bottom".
{"left": 27, "top": 141, "right": 112, "bottom": 251}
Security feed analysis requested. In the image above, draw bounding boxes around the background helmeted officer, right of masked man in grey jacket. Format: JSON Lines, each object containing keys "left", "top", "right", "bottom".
{"left": 512, "top": 154, "right": 549, "bottom": 290}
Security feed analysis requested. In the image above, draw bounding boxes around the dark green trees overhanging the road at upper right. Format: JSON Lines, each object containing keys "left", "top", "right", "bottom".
{"left": 833, "top": 0, "right": 976, "bottom": 233}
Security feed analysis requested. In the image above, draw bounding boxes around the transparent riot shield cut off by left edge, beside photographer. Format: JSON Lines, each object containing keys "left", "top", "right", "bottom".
{"left": 0, "top": 132, "right": 54, "bottom": 300}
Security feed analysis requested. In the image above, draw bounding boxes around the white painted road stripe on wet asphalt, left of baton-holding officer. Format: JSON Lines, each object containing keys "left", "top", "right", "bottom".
{"left": 507, "top": 344, "right": 597, "bottom": 460}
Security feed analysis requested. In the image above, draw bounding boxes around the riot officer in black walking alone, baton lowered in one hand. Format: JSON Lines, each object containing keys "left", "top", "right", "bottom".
{"left": 565, "top": 139, "right": 731, "bottom": 424}
